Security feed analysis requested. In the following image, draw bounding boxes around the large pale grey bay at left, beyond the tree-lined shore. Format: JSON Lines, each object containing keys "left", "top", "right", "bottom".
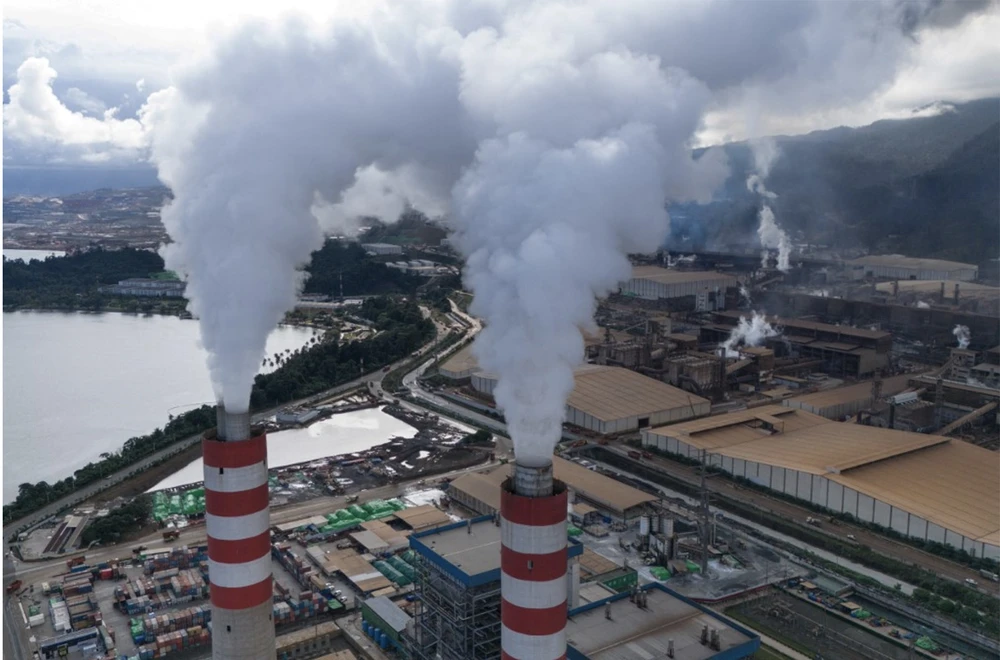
{"left": 3, "top": 311, "right": 314, "bottom": 503}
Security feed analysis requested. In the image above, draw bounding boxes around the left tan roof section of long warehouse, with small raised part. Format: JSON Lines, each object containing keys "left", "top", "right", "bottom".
{"left": 648, "top": 405, "right": 833, "bottom": 451}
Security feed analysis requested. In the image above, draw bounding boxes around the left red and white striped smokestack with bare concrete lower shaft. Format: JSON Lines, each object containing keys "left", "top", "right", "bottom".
{"left": 202, "top": 405, "right": 277, "bottom": 660}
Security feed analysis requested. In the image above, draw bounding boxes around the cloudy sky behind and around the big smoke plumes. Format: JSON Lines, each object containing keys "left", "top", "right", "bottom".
{"left": 3, "top": 0, "right": 1000, "bottom": 166}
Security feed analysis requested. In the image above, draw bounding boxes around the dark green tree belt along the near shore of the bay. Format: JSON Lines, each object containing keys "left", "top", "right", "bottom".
{"left": 3, "top": 296, "right": 434, "bottom": 524}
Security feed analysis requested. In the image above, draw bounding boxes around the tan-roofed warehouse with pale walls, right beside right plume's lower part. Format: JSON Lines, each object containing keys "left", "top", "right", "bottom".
{"left": 472, "top": 365, "right": 712, "bottom": 435}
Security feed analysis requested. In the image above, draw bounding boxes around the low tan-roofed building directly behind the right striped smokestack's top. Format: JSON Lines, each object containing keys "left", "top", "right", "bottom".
{"left": 448, "top": 456, "right": 657, "bottom": 520}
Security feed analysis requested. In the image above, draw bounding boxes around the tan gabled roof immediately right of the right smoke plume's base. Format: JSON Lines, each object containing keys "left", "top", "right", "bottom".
{"left": 568, "top": 365, "right": 709, "bottom": 421}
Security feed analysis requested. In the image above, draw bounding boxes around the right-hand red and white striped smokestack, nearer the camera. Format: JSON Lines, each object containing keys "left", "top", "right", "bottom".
{"left": 500, "top": 462, "right": 567, "bottom": 660}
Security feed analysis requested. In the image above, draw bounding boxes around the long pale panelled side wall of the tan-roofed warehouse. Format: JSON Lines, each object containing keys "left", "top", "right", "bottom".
{"left": 642, "top": 431, "right": 1000, "bottom": 560}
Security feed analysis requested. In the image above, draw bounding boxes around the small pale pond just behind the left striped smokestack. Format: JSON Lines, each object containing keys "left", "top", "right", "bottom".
{"left": 151, "top": 408, "right": 417, "bottom": 491}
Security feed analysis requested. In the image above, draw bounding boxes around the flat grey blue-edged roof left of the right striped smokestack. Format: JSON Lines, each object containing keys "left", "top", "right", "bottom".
{"left": 410, "top": 516, "right": 583, "bottom": 586}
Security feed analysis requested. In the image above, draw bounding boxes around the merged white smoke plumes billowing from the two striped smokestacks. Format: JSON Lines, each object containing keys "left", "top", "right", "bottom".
{"left": 111, "top": 0, "right": 992, "bottom": 454}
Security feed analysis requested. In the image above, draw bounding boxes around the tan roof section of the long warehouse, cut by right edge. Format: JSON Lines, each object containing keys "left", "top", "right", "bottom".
{"left": 831, "top": 438, "right": 1000, "bottom": 545}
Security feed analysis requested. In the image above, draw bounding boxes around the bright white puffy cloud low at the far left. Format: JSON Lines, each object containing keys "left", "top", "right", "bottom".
{"left": 3, "top": 58, "right": 147, "bottom": 162}
